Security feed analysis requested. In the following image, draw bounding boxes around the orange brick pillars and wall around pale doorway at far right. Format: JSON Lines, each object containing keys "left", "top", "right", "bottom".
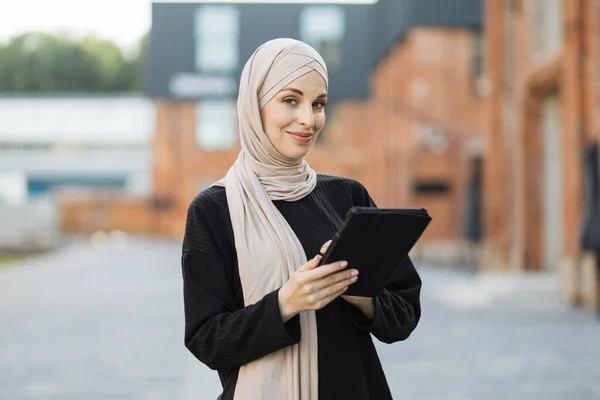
{"left": 482, "top": 0, "right": 598, "bottom": 312}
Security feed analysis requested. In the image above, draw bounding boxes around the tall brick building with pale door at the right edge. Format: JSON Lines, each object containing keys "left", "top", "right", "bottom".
{"left": 482, "top": 0, "right": 600, "bottom": 310}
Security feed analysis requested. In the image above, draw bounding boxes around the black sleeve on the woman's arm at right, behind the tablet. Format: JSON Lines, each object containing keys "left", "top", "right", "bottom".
{"left": 347, "top": 182, "right": 421, "bottom": 343}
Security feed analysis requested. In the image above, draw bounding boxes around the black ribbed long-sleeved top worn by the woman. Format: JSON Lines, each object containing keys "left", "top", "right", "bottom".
{"left": 182, "top": 175, "right": 421, "bottom": 400}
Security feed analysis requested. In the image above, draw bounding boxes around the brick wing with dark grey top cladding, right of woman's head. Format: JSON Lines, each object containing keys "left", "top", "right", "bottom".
{"left": 356, "top": 1, "right": 486, "bottom": 264}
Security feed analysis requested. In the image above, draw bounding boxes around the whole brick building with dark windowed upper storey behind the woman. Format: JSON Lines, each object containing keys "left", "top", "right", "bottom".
{"left": 137, "top": 0, "right": 484, "bottom": 253}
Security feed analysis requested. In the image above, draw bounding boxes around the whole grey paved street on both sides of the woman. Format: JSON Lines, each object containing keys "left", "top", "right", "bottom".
{"left": 0, "top": 240, "right": 600, "bottom": 400}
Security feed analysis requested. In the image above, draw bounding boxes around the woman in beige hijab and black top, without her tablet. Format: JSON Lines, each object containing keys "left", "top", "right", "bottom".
{"left": 182, "top": 39, "right": 421, "bottom": 400}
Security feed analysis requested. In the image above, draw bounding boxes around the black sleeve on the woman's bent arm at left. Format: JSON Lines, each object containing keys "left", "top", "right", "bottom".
{"left": 182, "top": 194, "right": 300, "bottom": 369}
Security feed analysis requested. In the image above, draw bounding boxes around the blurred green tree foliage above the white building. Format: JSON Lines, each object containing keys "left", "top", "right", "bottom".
{"left": 0, "top": 33, "right": 147, "bottom": 92}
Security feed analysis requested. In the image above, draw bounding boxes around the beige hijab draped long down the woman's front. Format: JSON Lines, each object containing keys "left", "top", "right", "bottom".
{"left": 215, "top": 39, "right": 327, "bottom": 400}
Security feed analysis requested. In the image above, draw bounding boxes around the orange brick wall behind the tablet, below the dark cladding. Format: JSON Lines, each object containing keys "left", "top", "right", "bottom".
{"left": 368, "top": 28, "right": 485, "bottom": 247}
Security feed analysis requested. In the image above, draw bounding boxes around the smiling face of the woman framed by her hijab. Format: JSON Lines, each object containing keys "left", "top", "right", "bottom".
{"left": 260, "top": 71, "right": 327, "bottom": 159}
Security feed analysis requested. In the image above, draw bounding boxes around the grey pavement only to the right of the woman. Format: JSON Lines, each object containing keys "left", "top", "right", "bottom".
{"left": 379, "top": 268, "right": 600, "bottom": 400}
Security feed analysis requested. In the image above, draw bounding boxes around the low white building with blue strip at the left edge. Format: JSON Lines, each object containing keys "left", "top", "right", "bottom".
{"left": 0, "top": 95, "right": 155, "bottom": 247}
